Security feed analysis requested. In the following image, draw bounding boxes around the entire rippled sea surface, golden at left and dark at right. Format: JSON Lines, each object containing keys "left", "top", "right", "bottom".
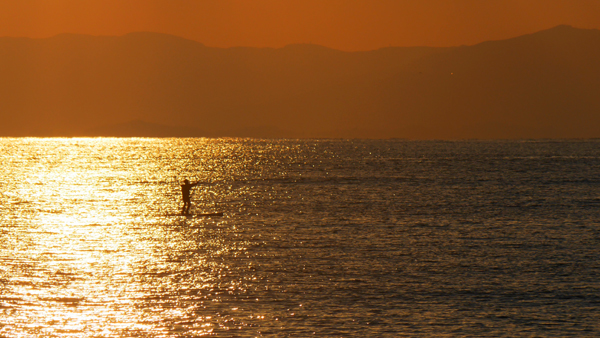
{"left": 0, "top": 138, "right": 600, "bottom": 337}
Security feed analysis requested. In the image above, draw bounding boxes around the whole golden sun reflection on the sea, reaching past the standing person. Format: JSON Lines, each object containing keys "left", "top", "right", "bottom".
{"left": 0, "top": 139, "right": 282, "bottom": 336}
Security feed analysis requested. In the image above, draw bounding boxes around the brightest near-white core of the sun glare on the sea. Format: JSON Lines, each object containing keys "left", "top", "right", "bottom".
{"left": 5, "top": 138, "right": 176, "bottom": 333}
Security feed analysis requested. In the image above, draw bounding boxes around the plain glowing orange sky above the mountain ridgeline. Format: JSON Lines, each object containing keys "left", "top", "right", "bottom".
{"left": 0, "top": 0, "right": 600, "bottom": 51}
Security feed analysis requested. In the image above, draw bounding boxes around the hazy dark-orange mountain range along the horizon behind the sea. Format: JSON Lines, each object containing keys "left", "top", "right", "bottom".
{"left": 0, "top": 26, "right": 600, "bottom": 139}
